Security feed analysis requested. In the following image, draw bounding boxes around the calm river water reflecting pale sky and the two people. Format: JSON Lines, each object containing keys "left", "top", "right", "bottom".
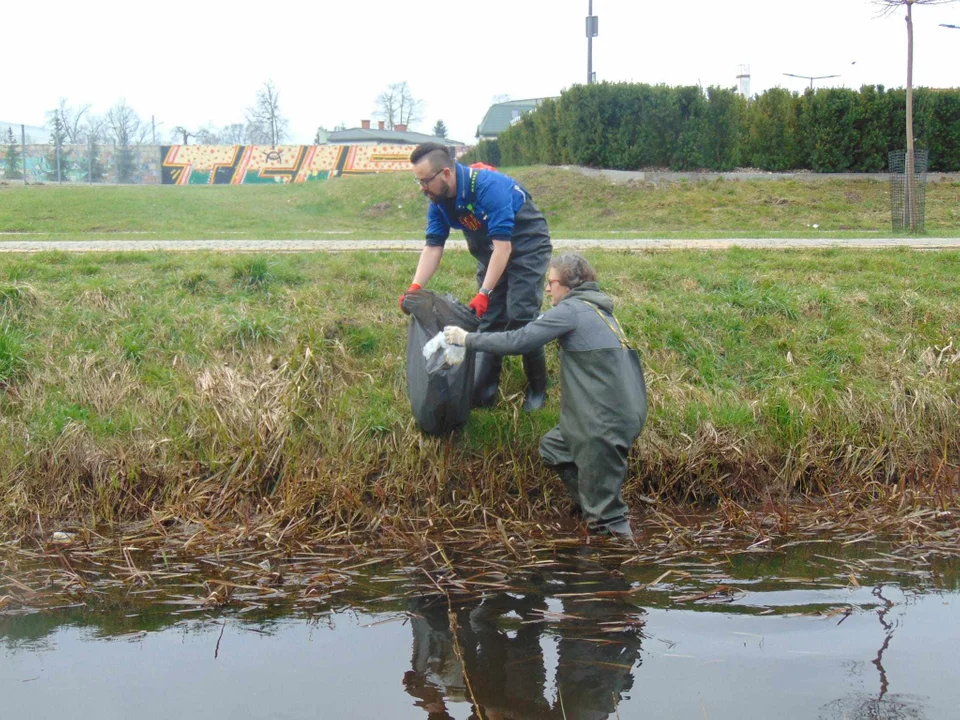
{"left": 0, "top": 543, "right": 960, "bottom": 720}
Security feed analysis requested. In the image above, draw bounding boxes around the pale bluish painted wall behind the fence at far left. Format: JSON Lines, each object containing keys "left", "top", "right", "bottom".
{"left": 0, "top": 126, "right": 160, "bottom": 185}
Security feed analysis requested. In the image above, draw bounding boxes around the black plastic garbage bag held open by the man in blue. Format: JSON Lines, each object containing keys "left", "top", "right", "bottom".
{"left": 403, "top": 290, "right": 480, "bottom": 435}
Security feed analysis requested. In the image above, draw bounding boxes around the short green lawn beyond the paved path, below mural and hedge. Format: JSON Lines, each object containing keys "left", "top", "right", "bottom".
{"left": 0, "top": 167, "right": 960, "bottom": 240}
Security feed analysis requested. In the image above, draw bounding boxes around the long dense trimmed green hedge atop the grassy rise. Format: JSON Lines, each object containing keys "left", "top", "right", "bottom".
{"left": 488, "top": 83, "right": 960, "bottom": 172}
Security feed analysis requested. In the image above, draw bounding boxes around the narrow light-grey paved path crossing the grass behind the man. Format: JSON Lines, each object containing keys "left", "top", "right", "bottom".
{"left": 0, "top": 237, "right": 960, "bottom": 253}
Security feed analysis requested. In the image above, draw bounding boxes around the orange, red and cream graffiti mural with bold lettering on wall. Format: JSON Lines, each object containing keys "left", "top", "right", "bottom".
{"left": 160, "top": 145, "right": 413, "bottom": 185}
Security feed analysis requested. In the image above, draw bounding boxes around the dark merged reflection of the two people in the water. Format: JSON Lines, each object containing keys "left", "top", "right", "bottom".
{"left": 404, "top": 562, "right": 640, "bottom": 720}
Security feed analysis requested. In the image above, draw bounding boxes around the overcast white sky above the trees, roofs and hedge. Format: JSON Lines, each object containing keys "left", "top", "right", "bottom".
{"left": 0, "top": 0, "right": 960, "bottom": 143}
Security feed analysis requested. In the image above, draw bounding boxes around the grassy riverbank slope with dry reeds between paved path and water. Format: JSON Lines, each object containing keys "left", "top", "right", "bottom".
{"left": 0, "top": 249, "right": 960, "bottom": 535}
